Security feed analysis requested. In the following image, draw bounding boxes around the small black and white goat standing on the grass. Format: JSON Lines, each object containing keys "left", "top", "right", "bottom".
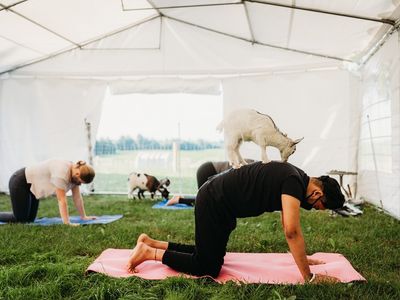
{"left": 128, "top": 172, "right": 170, "bottom": 199}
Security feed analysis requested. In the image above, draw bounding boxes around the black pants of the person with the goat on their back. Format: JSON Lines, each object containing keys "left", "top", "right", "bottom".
{"left": 162, "top": 187, "right": 236, "bottom": 277}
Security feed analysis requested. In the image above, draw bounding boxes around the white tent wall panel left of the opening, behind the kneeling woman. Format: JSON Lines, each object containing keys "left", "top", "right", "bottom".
{"left": 0, "top": 79, "right": 106, "bottom": 191}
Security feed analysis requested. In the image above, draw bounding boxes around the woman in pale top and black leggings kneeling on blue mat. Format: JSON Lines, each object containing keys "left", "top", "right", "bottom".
{"left": 0, "top": 159, "right": 97, "bottom": 225}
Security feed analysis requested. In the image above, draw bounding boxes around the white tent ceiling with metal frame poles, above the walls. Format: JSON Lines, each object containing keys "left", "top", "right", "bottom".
{"left": 0, "top": 0, "right": 400, "bottom": 76}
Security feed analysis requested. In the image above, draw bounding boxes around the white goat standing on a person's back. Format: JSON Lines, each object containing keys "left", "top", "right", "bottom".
{"left": 217, "top": 109, "right": 303, "bottom": 168}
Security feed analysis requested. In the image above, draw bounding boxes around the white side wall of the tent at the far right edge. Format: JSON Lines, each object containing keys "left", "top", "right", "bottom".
{"left": 358, "top": 31, "right": 400, "bottom": 218}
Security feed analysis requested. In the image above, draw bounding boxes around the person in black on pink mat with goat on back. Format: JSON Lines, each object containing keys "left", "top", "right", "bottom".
{"left": 129, "top": 161, "right": 344, "bottom": 282}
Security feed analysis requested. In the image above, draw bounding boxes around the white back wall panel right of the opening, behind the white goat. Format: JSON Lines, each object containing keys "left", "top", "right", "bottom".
{"left": 223, "top": 70, "right": 360, "bottom": 181}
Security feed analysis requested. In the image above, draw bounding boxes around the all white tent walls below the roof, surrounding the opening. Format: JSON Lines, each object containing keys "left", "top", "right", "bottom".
{"left": 0, "top": 38, "right": 400, "bottom": 217}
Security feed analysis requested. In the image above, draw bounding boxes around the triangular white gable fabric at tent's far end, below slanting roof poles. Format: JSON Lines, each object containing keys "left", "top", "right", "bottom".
{"left": 4, "top": 19, "right": 338, "bottom": 76}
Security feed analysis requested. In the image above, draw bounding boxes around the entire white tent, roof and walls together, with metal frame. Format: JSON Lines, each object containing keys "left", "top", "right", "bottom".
{"left": 0, "top": 0, "right": 400, "bottom": 217}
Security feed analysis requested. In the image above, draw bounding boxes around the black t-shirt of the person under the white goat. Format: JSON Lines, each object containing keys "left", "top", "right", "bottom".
{"left": 203, "top": 161, "right": 310, "bottom": 218}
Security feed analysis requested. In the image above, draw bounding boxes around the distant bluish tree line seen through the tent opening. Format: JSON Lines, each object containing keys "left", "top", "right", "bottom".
{"left": 94, "top": 134, "right": 223, "bottom": 155}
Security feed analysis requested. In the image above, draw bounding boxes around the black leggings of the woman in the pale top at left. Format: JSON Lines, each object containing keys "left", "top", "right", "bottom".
{"left": 0, "top": 168, "right": 39, "bottom": 222}
